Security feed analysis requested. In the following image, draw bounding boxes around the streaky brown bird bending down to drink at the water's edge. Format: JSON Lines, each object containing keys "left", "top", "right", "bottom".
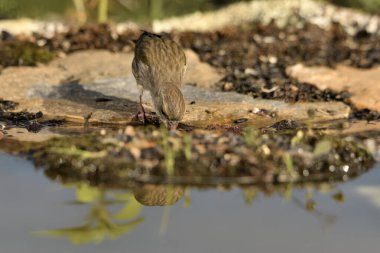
{"left": 132, "top": 31, "right": 186, "bottom": 130}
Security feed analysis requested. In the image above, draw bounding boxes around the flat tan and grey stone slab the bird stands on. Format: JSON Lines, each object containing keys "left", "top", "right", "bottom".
{"left": 0, "top": 51, "right": 350, "bottom": 127}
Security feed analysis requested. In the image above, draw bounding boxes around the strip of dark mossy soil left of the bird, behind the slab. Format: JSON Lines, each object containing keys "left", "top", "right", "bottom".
{"left": 0, "top": 23, "right": 140, "bottom": 67}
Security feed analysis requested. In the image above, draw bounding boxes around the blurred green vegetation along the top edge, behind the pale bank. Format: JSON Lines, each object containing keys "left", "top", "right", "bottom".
{"left": 0, "top": 0, "right": 380, "bottom": 23}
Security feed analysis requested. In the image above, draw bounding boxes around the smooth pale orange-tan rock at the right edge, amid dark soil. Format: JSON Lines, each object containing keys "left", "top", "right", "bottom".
{"left": 287, "top": 64, "right": 380, "bottom": 112}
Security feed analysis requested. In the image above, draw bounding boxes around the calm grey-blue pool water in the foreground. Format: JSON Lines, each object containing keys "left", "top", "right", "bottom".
{"left": 0, "top": 154, "right": 380, "bottom": 253}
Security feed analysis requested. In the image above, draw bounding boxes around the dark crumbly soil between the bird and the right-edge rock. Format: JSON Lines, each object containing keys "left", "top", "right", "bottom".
{"left": 178, "top": 23, "right": 380, "bottom": 110}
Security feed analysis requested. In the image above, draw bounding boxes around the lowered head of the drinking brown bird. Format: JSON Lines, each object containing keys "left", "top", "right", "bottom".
{"left": 152, "top": 85, "right": 185, "bottom": 130}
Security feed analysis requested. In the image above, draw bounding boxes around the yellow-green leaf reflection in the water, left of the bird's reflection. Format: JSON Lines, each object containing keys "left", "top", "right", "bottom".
{"left": 37, "top": 183, "right": 144, "bottom": 244}
